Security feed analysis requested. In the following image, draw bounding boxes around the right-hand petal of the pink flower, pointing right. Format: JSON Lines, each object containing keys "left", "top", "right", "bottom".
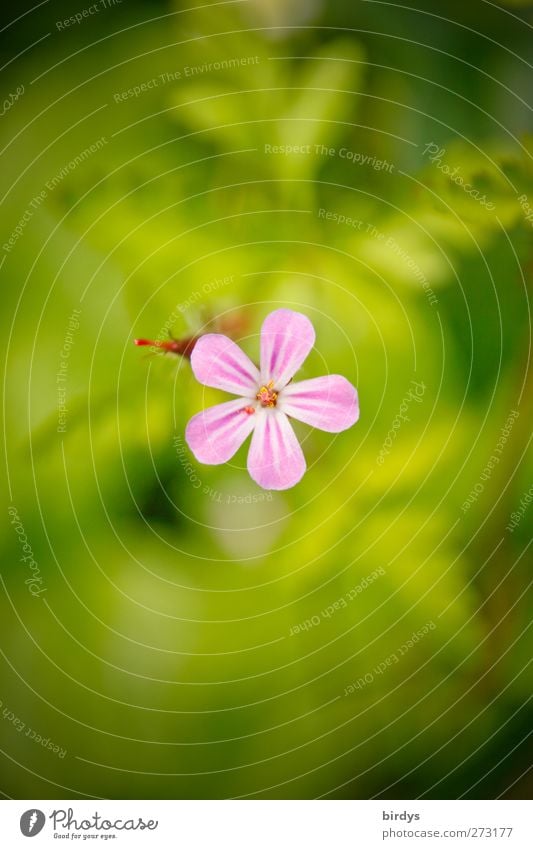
{"left": 278, "top": 374, "right": 359, "bottom": 433}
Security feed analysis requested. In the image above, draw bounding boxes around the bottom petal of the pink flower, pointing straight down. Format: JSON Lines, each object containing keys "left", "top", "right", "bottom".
{"left": 248, "top": 409, "right": 306, "bottom": 489}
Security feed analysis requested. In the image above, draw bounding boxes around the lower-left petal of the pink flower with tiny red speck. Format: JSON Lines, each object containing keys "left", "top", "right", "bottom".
{"left": 185, "top": 398, "right": 258, "bottom": 466}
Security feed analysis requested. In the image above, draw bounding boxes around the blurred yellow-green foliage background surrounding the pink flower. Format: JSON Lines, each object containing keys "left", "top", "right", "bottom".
{"left": 0, "top": 0, "right": 533, "bottom": 798}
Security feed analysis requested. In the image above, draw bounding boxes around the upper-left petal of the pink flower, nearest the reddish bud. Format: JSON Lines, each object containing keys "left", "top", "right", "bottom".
{"left": 191, "top": 333, "right": 259, "bottom": 398}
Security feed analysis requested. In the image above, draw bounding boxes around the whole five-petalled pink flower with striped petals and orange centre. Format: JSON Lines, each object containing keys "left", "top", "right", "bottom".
{"left": 185, "top": 309, "right": 359, "bottom": 489}
